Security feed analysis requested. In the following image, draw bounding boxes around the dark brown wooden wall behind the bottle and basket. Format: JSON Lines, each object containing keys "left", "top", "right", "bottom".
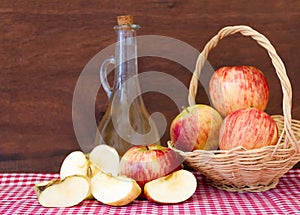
{"left": 0, "top": 0, "right": 300, "bottom": 172}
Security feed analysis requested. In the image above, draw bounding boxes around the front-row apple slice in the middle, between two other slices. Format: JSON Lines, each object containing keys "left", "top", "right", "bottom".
{"left": 91, "top": 171, "right": 142, "bottom": 206}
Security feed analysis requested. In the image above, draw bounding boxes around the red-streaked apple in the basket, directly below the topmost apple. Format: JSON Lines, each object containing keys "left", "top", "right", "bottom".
{"left": 219, "top": 108, "right": 278, "bottom": 150}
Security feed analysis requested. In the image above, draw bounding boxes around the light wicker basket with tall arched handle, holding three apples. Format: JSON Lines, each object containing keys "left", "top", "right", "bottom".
{"left": 168, "top": 26, "right": 300, "bottom": 192}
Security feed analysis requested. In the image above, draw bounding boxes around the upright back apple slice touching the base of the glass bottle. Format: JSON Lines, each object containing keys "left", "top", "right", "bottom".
{"left": 88, "top": 144, "right": 120, "bottom": 176}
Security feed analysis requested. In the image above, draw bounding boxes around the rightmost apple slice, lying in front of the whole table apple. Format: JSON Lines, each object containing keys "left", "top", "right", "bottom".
{"left": 144, "top": 169, "right": 197, "bottom": 204}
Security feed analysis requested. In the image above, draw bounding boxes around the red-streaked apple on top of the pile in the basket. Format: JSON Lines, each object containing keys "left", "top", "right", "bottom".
{"left": 209, "top": 66, "right": 269, "bottom": 116}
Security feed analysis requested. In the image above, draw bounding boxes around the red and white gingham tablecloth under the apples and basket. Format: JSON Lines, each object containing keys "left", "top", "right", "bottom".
{"left": 0, "top": 169, "right": 300, "bottom": 215}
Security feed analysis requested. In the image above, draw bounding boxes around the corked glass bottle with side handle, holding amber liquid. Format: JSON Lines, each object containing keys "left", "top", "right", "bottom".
{"left": 95, "top": 16, "right": 160, "bottom": 156}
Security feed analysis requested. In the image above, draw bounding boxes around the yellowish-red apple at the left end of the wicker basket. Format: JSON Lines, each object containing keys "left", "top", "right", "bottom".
{"left": 170, "top": 104, "right": 223, "bottom": 151}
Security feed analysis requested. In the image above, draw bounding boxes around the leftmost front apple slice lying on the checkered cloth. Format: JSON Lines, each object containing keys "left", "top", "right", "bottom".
{"left": 34, "top": 175, "right": 90, "bottom": 207}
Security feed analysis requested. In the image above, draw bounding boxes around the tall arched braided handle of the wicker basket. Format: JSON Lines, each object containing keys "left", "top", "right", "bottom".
{"left": 188, "top": 25, "right": 299, "bottom": 152}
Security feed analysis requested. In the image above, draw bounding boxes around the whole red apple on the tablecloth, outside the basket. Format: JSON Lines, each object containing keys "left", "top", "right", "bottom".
{"left": 119, "top": 144, "right": 183, "bottom": 188}
